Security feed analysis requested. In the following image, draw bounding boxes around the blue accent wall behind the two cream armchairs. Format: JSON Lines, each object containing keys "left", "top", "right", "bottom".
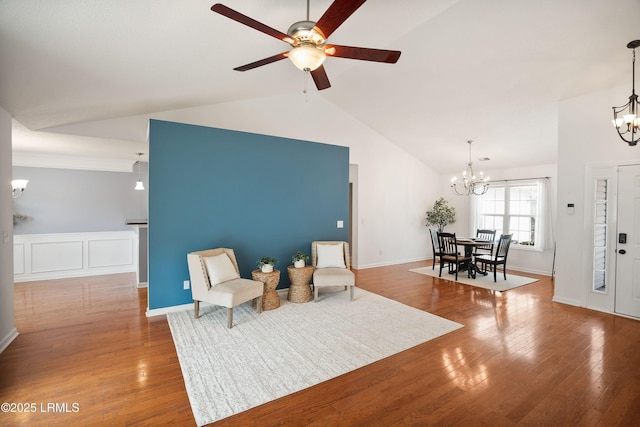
{"left": 148, "top": 120, "right": 349, "bottom": 309}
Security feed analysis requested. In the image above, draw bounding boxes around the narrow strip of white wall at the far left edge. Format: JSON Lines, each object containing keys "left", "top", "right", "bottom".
{"left": 0, "top": 108, "right": 17, "bottom": 352}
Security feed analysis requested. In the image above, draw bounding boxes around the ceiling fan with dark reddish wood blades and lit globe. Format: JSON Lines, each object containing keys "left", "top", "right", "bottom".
{"left": 211, "top": 0, "right": 401, "bottom": 90}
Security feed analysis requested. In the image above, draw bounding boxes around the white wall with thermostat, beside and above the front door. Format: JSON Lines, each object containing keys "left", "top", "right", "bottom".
{"left": 554, "top": 86, "right": 640, "bottom": 307}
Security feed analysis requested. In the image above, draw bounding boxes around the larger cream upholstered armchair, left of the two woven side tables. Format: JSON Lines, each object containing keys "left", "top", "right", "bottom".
{"left": 187, "top": 248, "right": 264, "bottom": 328}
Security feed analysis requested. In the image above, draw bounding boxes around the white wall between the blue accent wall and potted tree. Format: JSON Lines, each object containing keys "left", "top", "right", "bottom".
{"left": 351, "top": 128, "right": 440, "bottom": 268}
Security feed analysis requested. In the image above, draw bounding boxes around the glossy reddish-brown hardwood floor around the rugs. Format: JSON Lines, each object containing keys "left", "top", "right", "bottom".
{"left": 0, "top": 262, "right": 640, "bottom": 426}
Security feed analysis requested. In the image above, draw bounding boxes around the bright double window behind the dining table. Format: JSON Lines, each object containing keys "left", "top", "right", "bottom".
{"left": 475, "top": 180, "right": 544, "bottom": 250}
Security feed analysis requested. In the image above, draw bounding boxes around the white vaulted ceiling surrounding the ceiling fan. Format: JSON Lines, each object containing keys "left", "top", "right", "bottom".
{"left": 0, "top": 0, "right": 640, "bottom": 173}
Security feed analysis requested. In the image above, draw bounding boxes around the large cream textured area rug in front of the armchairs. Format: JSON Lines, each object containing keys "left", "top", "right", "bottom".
{"left": 167, "top": 288, "right": 462, "bottom": 425}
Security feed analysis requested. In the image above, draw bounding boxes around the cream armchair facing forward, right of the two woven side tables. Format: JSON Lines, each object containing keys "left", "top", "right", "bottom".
{"left": 311, "top": 241, "right": 356, "bottom": 302}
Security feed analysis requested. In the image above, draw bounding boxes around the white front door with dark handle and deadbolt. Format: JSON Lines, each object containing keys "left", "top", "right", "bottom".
{"left": 614, "top": 165, "right": 640, "bottom": 318}
